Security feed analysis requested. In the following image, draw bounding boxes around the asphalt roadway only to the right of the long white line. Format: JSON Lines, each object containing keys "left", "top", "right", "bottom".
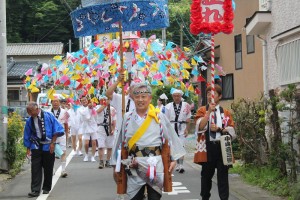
{"left": 47, "top": 152, "right": 237, "bottom": 200}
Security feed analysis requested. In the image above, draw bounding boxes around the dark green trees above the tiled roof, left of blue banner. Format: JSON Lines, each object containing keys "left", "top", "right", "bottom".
{"left": 6, "top": 0, "right": 80, "bottom": 48}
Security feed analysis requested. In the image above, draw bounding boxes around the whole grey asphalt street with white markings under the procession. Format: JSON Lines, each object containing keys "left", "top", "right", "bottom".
{"left": 0, "top": 149, "right": 238, "bottom": 200}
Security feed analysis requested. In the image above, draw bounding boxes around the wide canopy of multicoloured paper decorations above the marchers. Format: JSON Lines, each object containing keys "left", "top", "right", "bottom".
{"left": 26, "top": 36, "right": 204, "bottom": 103}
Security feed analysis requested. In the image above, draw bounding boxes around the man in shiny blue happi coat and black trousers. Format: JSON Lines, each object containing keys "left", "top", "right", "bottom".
{"left": 24, "top": 102, "right": 65, "bottom": 197}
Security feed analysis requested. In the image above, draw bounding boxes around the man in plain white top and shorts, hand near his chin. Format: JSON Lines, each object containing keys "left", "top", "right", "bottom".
{"left": 78, "top": 97, "right": 97, "bottom": 162}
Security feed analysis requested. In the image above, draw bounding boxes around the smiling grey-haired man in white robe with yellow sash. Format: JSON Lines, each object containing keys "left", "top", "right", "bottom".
{"left": 112, "top": 83, "right": 185, "bottom": 200}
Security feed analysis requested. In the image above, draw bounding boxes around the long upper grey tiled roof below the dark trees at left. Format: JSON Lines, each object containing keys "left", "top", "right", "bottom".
{"left": 7, "top": 42, "right": 64, "bottom": 56}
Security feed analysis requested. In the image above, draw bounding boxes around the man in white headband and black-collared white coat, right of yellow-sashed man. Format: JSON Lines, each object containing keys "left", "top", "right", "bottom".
{"left": 166, "top": 89, "right": 191, "bottom": 173}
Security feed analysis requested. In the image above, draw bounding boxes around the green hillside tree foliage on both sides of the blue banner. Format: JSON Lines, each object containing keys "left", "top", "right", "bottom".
{"left": 6, "top": 0, "right": 195, "bottom": 50}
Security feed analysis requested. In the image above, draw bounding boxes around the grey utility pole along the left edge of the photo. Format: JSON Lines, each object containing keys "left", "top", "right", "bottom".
{"left": 0, "top": 1, "right": 8, "bottom": 170}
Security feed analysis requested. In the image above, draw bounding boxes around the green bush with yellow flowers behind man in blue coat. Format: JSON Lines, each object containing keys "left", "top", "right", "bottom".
{"left": 5, "top": 113, "right": 26, "bottom": 176}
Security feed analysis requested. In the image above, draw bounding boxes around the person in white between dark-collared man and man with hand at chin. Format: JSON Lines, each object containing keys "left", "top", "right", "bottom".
{"left": 66, "top": 103, "right": 83, "bottom": 156}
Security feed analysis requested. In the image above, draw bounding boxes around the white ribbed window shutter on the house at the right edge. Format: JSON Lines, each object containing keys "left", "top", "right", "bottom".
{"left": 277, "top": 39, "right": 300, "bottom": 85}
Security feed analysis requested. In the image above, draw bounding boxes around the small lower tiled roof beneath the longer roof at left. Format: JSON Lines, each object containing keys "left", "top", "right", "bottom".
{"left": 7, "top": 61, "right": 40, "bottom": 79}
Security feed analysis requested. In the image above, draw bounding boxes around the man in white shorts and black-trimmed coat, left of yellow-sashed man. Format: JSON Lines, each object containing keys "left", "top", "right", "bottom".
{"left": 96, "top": 98, "right": 117, "bottom": 169}
